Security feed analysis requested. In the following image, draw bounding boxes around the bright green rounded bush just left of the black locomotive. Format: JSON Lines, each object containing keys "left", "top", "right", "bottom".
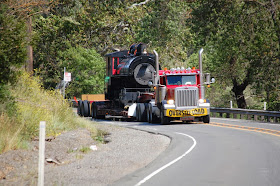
{"left": 59, "top": 47, "right": 105, "bottom": 97}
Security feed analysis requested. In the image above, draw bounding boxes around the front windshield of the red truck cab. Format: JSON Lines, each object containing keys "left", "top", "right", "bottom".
{"left": 167, "top": 75, "right": 196, "bottom": 85}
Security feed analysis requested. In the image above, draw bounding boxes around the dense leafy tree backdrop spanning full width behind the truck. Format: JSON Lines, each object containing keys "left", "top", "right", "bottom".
{"left": 0, "top": 0, "right": 280, "bottom": 110}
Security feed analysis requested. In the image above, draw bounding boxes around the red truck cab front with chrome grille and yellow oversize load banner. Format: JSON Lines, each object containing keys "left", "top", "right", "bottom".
{"left": 155, "top": 68, "right": 210, "bottom": 123}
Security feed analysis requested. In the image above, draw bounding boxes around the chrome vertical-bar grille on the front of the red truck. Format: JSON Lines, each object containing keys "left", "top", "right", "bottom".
{"left": 175, "top": 88, "right": 198, "bottom": 108}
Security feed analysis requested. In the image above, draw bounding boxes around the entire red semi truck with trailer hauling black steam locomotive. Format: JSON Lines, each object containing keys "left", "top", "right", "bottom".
{"left": 78, "top": 43, "right": 214, "bottom": 124}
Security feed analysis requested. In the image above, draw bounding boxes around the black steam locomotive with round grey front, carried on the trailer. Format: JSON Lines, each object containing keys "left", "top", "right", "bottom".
{"left": 105, "top": 43, "right": 159, "bottom": 106}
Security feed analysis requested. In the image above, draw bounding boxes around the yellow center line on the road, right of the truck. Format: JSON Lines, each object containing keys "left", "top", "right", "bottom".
{"left": 195, "top": 122, "right": 280, "bottom": 137}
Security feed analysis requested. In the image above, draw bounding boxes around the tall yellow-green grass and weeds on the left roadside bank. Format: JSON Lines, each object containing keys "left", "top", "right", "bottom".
{"left": 0, "top": 73, "right": 99, "bottom": 154}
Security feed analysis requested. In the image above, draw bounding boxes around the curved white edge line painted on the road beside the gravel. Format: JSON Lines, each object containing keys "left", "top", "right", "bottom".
{"left": 135, "top": 132, "right": 196, "bottom": 186}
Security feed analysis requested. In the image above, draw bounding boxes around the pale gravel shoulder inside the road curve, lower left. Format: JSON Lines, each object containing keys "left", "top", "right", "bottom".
{"left": 0, "top": 121, "right": 170, "bottom": 185}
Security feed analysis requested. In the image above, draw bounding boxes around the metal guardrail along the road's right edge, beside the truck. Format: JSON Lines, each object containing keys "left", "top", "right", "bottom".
{"left": 210, "top": 107, "right": 280, "bottom": 123}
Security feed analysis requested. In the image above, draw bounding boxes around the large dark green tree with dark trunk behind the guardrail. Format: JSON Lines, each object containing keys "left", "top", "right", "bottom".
{"left": 191, "top": 0, "right": 278, "bottom": 108}
